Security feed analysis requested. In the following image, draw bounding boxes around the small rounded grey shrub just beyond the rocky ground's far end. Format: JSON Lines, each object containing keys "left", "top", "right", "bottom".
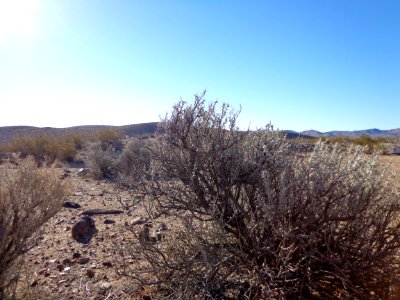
{"left": 88, "top": 143, "right": 117, "bottom": 179}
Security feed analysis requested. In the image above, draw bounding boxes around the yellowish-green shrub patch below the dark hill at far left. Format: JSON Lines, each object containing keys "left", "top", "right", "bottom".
{"left": 9, "top": 135, "right": 76, "bottom": 163}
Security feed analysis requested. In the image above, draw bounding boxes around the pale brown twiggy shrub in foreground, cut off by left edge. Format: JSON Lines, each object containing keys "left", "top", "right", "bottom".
{"left": 0, "top": 158, "right": 66, "bottom": 299}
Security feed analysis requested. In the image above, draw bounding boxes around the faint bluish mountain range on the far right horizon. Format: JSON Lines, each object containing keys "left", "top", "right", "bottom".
{"left": 300, "top": 128, "right": 400, "bottom": 137}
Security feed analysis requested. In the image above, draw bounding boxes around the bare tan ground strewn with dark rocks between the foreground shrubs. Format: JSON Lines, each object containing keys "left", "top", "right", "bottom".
{"left": 9, "top": 163, "right": 161, "bottom": 299}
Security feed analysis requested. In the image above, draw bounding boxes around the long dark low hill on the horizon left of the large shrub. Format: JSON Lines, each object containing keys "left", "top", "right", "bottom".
{"left": 0, "top": 122, "right": 158, "bottom": 143}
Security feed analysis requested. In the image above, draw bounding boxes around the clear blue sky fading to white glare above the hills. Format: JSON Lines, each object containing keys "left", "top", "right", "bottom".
{"left": 0, "top": 0, "right": 400, "bottom": 131}
